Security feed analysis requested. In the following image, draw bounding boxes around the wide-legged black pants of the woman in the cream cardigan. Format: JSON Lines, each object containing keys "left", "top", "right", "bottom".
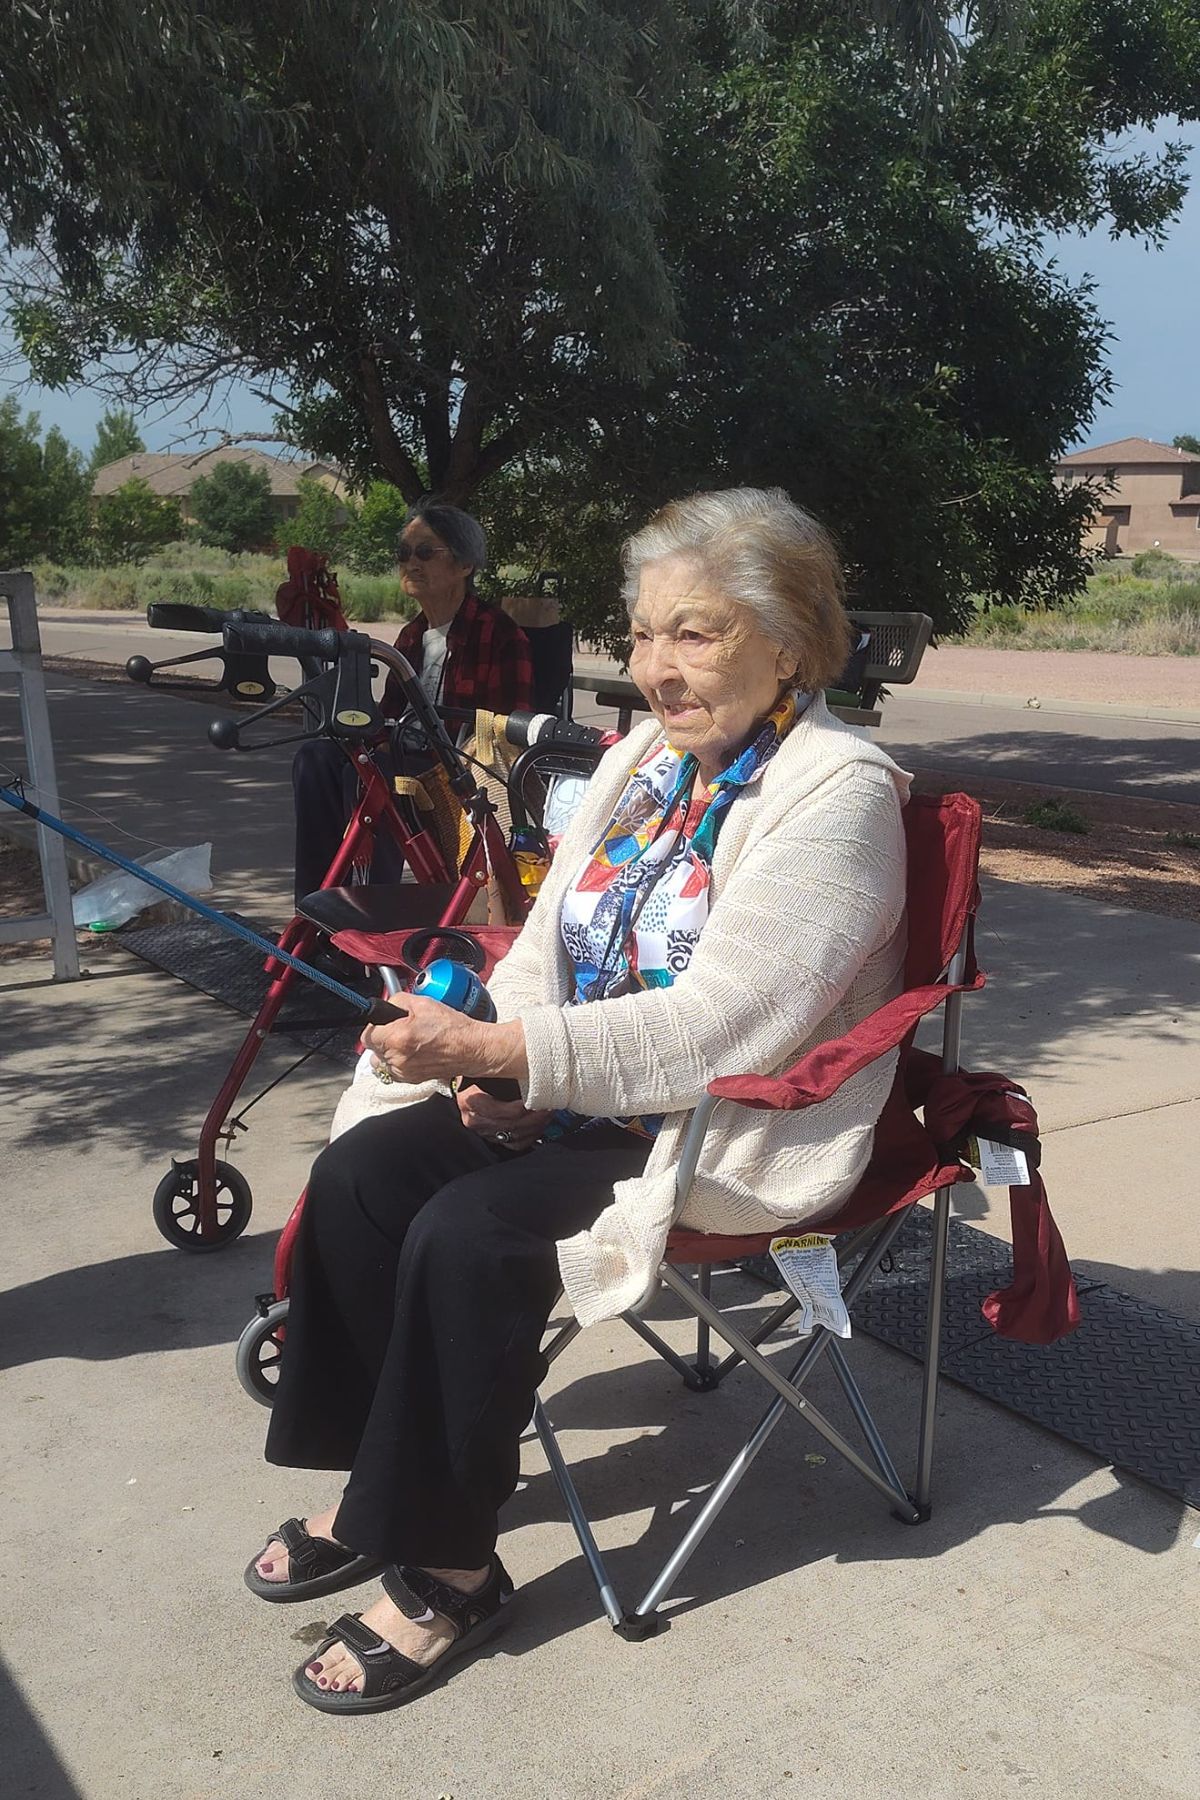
{"left": 266, "top": 1096, "right": 649, "bottom": 1568}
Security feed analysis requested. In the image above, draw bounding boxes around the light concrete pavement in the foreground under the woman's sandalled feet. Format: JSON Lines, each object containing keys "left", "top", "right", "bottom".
{"left": 0, "top": 958, "right": 1200, "bottom": 1800}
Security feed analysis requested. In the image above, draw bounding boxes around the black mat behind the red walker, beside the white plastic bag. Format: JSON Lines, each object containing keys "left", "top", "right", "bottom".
{"left": 119, "top": 913, "right": 367, "bottom": 1064}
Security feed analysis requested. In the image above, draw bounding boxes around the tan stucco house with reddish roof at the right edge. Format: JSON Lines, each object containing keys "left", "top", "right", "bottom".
{"left": 1056, "top": 437, "right": 1200, "bottom": 562}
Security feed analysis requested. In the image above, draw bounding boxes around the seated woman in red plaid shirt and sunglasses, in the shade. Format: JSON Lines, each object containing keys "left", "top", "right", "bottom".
{"left": 291, "top": 502, "right": 533, "bottom": 907}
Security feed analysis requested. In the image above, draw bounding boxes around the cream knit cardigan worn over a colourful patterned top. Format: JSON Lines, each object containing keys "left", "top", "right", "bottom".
{"left": 333, "top": 697, "right": 909, "bottom": 1325}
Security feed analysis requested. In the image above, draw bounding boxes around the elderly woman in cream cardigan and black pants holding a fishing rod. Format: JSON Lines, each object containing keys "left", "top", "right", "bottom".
{"left": 246, "top": 488, "right": 907, "bottom": 1714}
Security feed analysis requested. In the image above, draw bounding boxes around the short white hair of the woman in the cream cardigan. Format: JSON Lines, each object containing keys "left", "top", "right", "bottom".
{"left": 622, "top": 488, "right": 851, "bottom": 691}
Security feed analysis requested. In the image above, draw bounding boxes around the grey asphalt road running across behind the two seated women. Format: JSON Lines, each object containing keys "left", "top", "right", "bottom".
{"left": 9, "top": 612, "right": 1200, "bottom": 805}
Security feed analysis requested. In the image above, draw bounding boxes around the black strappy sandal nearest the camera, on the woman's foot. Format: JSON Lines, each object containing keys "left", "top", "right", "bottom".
{"left": 291, "top": 1557, "right": 513, "bottom": 1714}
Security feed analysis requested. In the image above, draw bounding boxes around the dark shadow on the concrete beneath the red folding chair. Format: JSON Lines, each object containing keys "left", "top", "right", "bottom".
{"left": 500, "top": 1310, "right": 1184, "bottom": 1654}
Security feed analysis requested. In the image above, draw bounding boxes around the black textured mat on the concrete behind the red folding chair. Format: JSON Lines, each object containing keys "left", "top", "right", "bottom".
{"left": 855, "top": 1206, "right": 1200, "bottom": 1507}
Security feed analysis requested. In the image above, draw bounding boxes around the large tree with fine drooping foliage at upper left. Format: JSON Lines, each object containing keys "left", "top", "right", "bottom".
{"left": 0, "top": 0, "right": 1015, "bottom": 500}
